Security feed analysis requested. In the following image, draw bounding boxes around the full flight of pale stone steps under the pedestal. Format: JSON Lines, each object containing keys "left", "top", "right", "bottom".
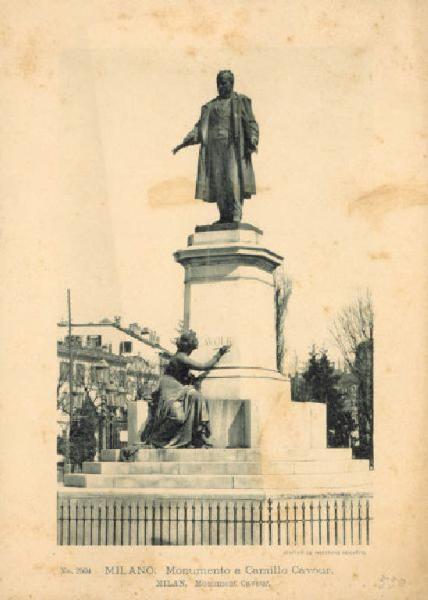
{"left": 64, "top": 449, "right": 372, "bottom": 493}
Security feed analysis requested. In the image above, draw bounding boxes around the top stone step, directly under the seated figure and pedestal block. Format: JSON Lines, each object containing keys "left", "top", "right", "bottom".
{"left": 101, "top": 448, "right": 352, "bottom": 462}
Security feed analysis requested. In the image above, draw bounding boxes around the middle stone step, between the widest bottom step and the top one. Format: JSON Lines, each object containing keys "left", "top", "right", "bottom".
{"left": 83, "top": 459, "right": 369, "bottom": 475}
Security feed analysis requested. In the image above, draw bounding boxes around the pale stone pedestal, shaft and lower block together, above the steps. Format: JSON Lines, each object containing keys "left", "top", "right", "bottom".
{"left": 174, "top": 223, "right": 326, "bottom": 456}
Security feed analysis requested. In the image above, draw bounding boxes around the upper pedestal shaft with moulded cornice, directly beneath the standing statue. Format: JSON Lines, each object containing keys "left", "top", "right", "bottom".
{"left": 174, "top": 224, "right": 283, "bottom": 372}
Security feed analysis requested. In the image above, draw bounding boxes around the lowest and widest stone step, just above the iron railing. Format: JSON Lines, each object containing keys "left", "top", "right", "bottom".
{"left": 64, "top": 471, "right": 373, "bottom": 490}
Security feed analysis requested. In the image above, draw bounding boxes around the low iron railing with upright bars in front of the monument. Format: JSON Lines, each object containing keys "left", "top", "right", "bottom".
{"left": 57, "top": 496, "right": 372, "bottom": 546}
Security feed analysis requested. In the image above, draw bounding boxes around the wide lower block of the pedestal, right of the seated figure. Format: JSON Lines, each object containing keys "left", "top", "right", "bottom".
{"left": 202, "top": 367, "right": 327, "bottom": 457}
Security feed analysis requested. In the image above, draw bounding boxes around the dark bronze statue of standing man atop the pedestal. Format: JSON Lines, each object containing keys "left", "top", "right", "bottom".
{"left": 173, "top": 71, "right": 259, "bottom": 223}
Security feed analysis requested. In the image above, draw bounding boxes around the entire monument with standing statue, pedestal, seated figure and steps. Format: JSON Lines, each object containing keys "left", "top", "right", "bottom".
{"left": 61, "top": 71, "right": 370, "bottom": 499}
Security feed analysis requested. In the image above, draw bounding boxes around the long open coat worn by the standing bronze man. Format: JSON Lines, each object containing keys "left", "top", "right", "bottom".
{"left": 183, "top": 92, "right": 259, "bottom": 202}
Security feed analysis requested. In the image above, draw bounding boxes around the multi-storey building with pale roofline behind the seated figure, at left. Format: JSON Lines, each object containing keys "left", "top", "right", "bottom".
{"left": 57, "top": 317, "right": 165, "bottom": 454}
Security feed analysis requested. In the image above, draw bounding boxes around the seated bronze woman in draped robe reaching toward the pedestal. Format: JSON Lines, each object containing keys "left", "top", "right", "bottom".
{"left": 141, "top": 330, "right": 230, "bottom": 448}
